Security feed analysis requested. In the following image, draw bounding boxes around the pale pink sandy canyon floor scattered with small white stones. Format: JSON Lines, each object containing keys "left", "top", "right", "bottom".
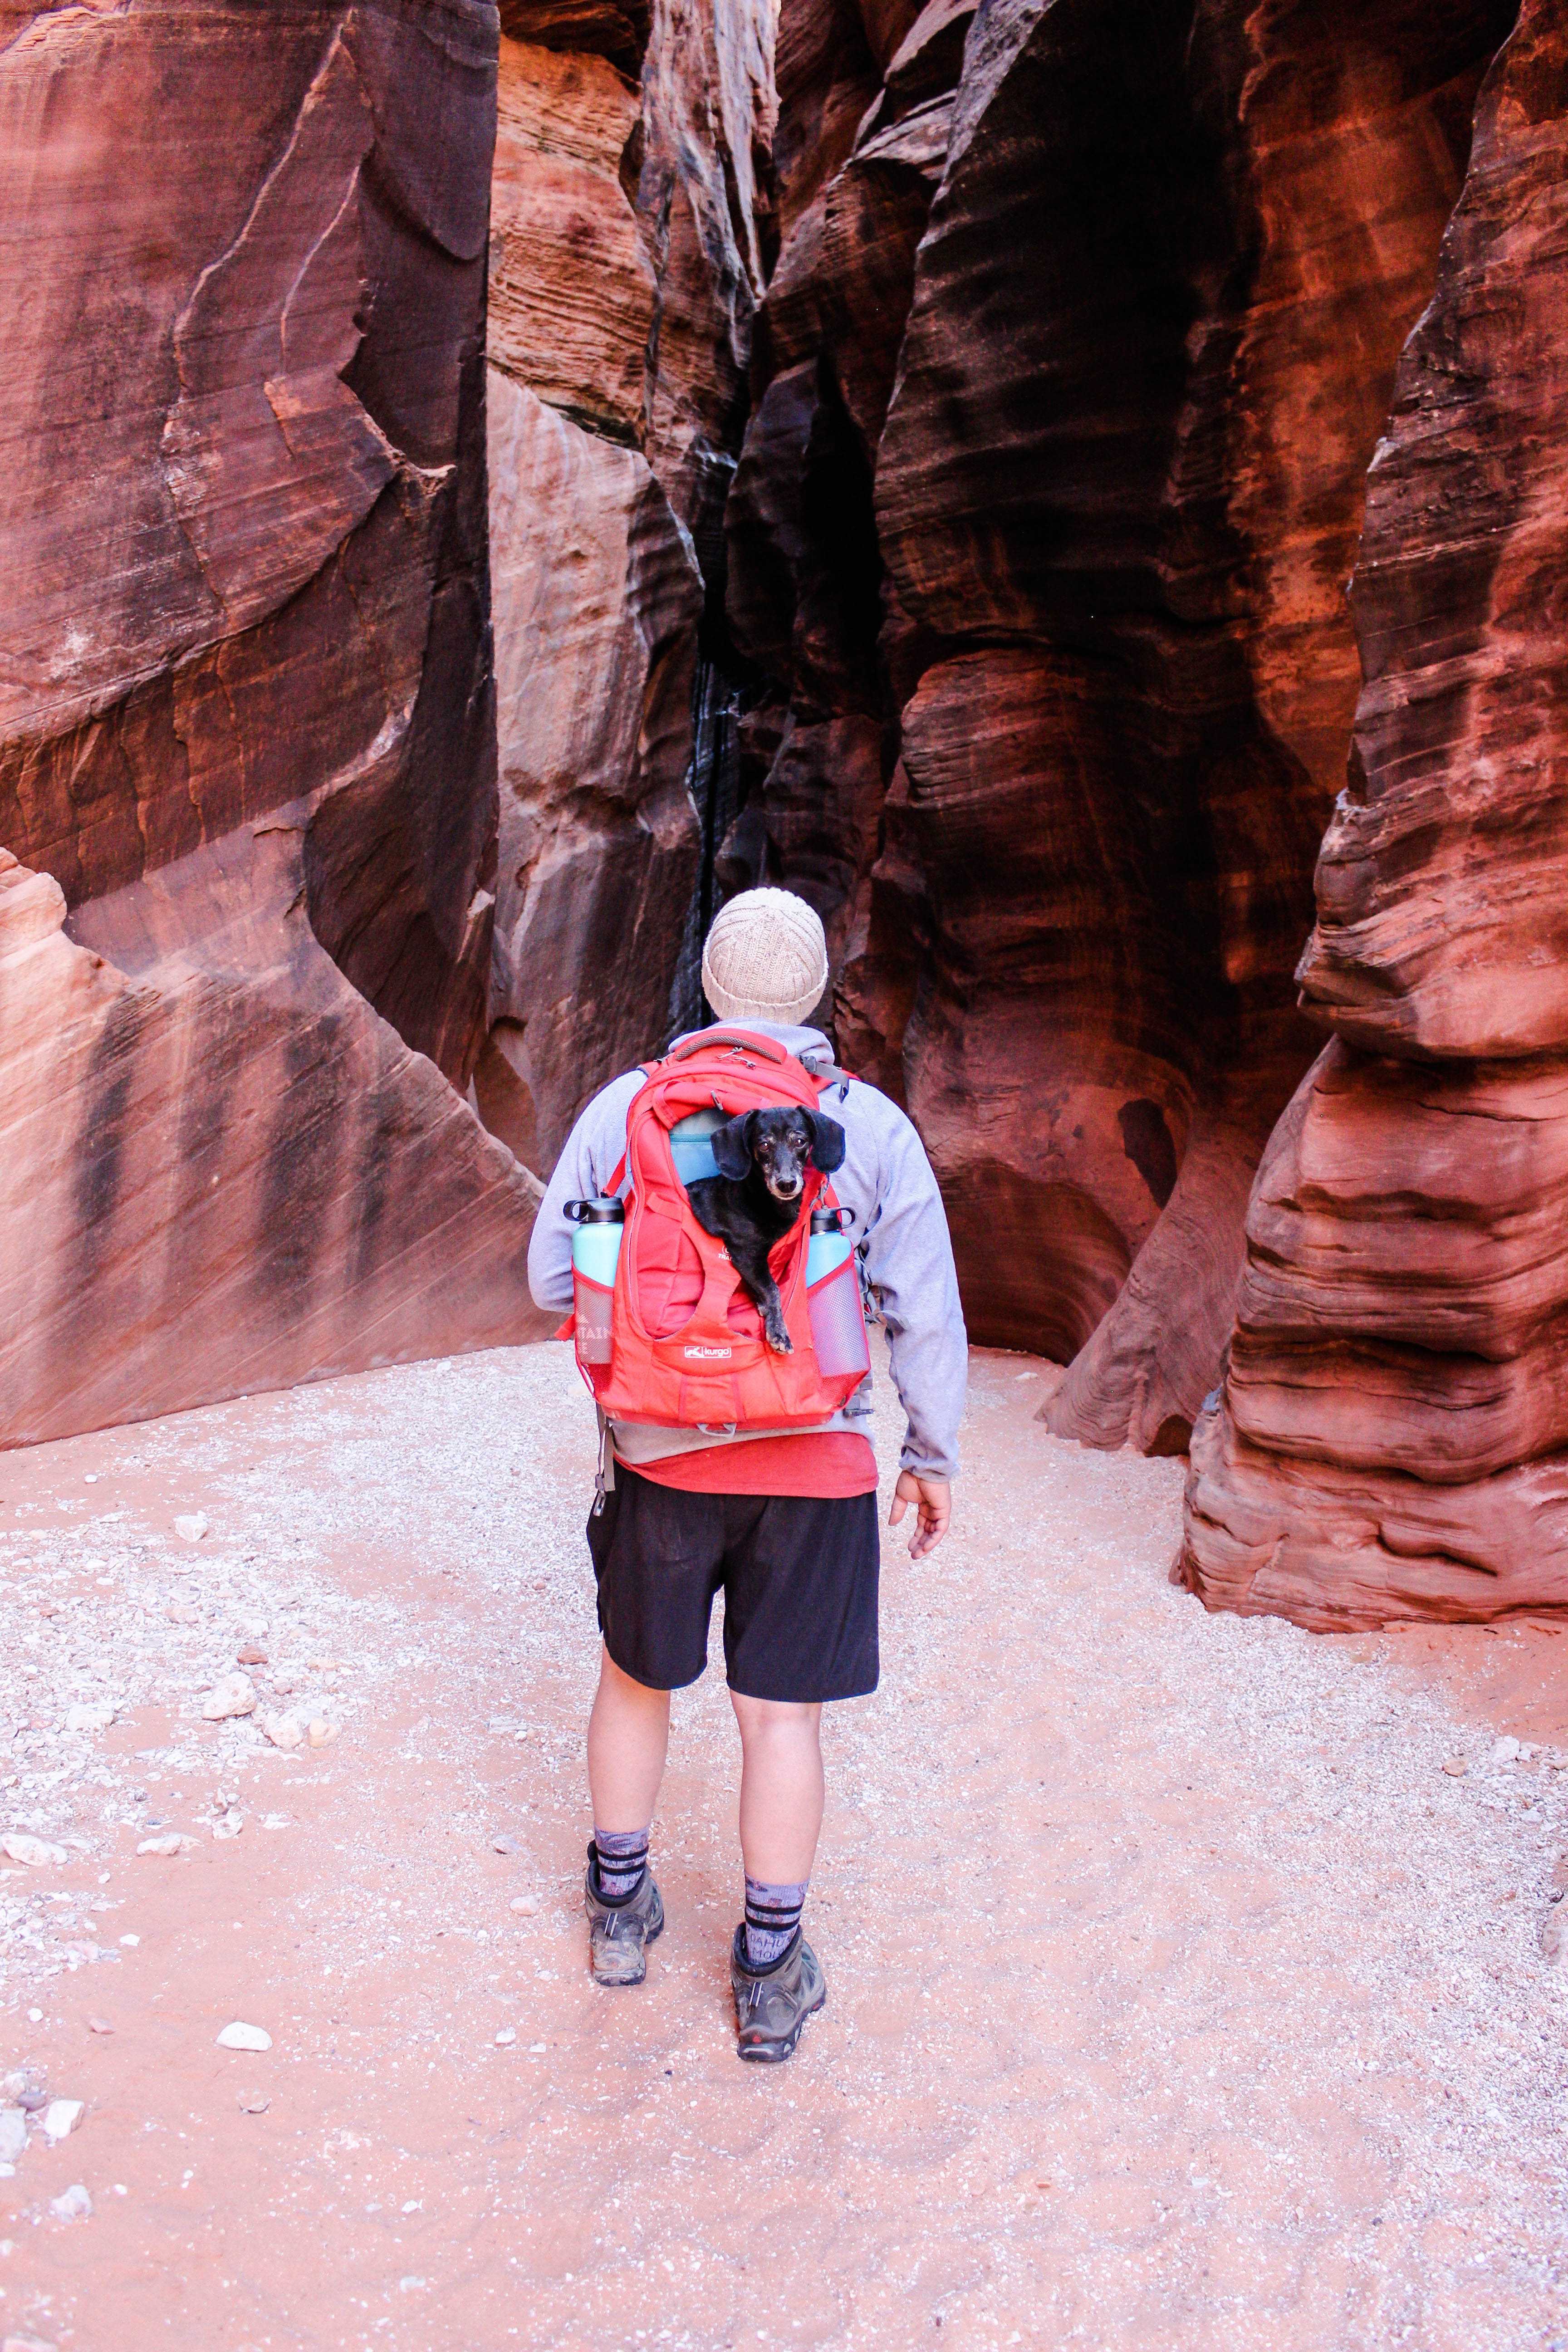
{"left": 0, "top": 1345, "right": 1568, "bottom": 2352}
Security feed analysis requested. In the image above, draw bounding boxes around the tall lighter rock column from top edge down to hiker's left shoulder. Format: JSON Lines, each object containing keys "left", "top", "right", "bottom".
{"left": 475, "top": 0, "right": 771, "bottom": 1174}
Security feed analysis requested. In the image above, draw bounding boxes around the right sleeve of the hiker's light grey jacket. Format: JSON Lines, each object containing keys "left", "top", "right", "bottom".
{"left": 865, "top": 1096, "right": 969, "bottom": 1477}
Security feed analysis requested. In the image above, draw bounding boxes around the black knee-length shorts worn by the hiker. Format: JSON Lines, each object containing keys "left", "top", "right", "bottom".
{"left": 588, "top": 1463, "right": 879, "bottom": 1700}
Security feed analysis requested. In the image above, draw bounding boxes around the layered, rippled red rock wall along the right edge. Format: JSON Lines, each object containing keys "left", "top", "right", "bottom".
{"left": 1182, "top": 5, "right": 1568, "bottom": 1625}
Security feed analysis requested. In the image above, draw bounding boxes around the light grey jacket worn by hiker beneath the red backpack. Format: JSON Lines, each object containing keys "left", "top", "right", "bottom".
{"left": 529, "top": 1021, "right": 969, "bottom": 1477}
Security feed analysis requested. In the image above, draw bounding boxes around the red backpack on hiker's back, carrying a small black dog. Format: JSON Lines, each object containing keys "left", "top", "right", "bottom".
{"left": 562, "top": 1028, "right": 863, "bottom": 1430}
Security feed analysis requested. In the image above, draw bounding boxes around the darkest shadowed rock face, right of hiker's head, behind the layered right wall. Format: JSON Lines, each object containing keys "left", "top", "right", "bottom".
{"left": 726, "top": 0, "right": 1509, "bottom": 1449}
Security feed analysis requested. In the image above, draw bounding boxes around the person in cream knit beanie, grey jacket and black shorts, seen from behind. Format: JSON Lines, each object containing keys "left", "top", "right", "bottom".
{"left": 529, "top": 889, "right": 969, "bottom": 2063}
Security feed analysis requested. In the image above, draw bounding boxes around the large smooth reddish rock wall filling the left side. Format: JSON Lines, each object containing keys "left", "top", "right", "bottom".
{"left": 0, "top": 0, "right": 557, "bottom": 1442}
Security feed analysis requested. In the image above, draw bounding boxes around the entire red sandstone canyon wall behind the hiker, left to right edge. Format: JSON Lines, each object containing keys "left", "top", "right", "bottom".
{"left": 0, "top": 0, "right": 1568, "bottom": 1571}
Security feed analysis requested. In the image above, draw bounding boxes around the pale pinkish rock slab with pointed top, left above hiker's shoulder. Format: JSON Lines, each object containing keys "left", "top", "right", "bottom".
{"left": 477, "top": 376, "right": 703, "bottom": 1171}
